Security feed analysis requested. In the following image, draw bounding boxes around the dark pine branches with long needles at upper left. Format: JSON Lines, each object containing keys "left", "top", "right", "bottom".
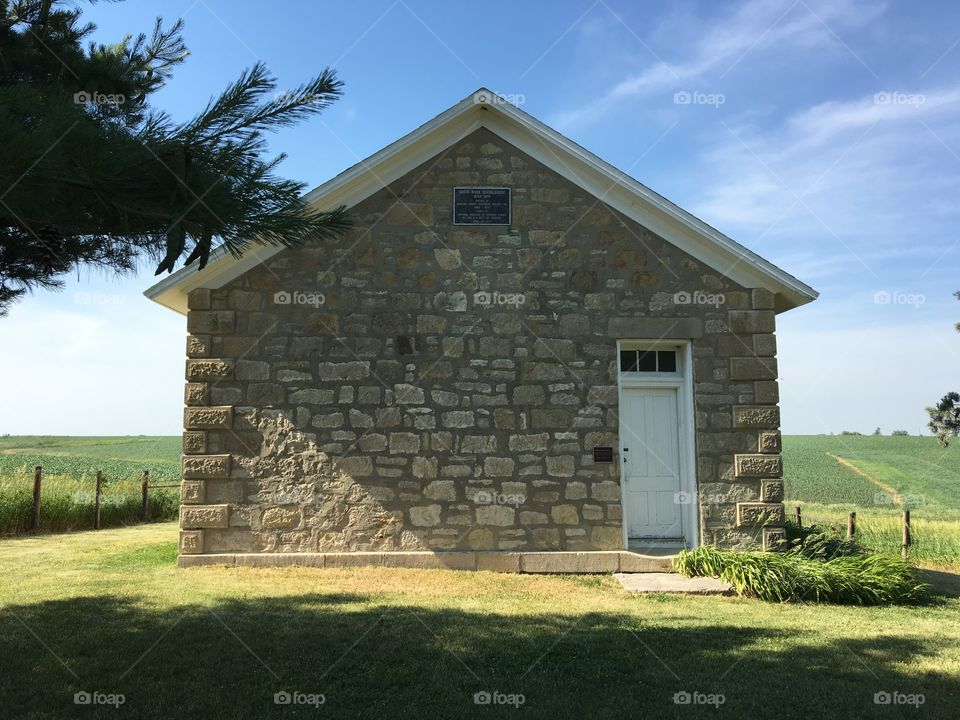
{"left": 0, "top": 0, "right": 348, "bottom": 315}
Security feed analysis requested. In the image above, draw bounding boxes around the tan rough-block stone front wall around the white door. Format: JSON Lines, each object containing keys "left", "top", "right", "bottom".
{"left": 181, "top": 130, "right": 783, "bottom": 555}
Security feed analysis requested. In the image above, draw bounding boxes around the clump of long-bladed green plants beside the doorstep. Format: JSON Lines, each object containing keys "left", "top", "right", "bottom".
{"left": 674, "top": 546, "right": 928, "bottom": 605}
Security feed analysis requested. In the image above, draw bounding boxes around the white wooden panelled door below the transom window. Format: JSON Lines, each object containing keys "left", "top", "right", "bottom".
{"left": 620, "top": 388, "right": 684, "bottom": 538}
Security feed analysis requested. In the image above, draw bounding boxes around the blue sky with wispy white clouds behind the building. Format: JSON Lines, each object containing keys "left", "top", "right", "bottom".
{"left": 0, "top": 0, "right": 960, "bottom": 435}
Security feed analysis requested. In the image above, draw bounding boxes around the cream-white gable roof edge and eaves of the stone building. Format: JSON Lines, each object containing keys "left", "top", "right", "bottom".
{"left": 144, "top": 88, "right": 818, "bottom": 314}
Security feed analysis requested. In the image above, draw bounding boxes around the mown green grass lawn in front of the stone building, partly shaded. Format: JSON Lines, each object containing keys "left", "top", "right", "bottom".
{"left": 0, "top": 524, "right": 960, "bottom": 720}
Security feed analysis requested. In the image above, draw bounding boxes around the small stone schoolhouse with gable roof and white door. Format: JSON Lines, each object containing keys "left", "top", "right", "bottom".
{"left": 146, "top": 89, "right": 816, "bottom": 572}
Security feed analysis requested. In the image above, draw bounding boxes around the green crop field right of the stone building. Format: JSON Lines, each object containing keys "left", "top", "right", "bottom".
{"left": 783, "top": 435, "right": 960, "bottom": 566}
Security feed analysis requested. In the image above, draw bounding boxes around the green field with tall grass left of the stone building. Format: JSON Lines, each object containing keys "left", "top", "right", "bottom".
{"left": 0, "top": 435, "right": 180, "bottom": 535}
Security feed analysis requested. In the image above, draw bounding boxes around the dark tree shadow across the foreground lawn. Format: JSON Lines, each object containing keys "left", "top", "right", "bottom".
{"left": 0, "top": 594, "right": 956, "bottom": 720}
